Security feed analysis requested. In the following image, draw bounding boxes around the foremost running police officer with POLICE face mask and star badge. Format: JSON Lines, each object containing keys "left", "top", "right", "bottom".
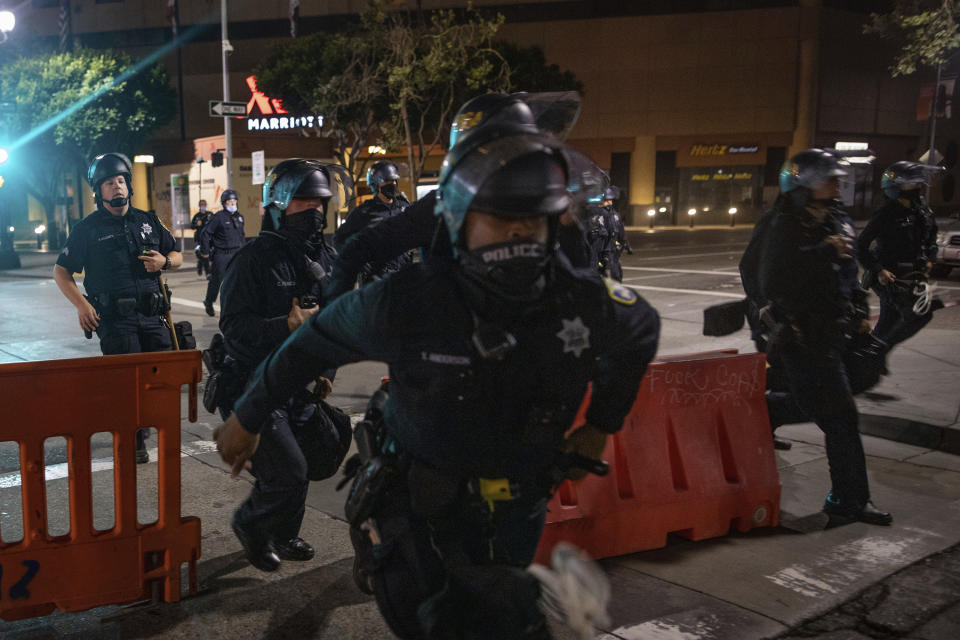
{"left": 216, "top": 134, "right": 659, "bottom": 639}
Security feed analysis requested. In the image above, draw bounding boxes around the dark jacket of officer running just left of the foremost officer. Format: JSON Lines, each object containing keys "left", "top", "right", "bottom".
{"left": 220, "top": 231, "right": 335, "bottom": 370}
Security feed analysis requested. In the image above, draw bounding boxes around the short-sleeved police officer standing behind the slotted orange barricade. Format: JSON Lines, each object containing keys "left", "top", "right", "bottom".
{"left": 53, "top": 153, "right": 183, "bottom": 463}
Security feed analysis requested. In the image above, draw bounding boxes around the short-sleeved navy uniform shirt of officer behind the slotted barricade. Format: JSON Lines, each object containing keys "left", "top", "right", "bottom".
{"left": 57, "top": 207, "right": 176, "bottom": 298}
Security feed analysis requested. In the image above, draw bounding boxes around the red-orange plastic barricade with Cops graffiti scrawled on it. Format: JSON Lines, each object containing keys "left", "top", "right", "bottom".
{"left": 536, "top": 352, "right": 780, "bottom": 563}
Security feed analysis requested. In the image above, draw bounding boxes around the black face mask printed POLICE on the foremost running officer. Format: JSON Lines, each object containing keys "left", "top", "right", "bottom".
{"left": 460, "top": 242, "right": 549, "bottom": 301}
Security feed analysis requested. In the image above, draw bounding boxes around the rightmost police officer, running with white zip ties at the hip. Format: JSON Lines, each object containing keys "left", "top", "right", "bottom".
{"left": 858, "top": 160, "right": 939, "bottom": 349}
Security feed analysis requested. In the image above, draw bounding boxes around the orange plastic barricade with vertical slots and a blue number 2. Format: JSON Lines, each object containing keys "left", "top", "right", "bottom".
{"left": 0, "top": 351, "right": 201, "bottom": 620}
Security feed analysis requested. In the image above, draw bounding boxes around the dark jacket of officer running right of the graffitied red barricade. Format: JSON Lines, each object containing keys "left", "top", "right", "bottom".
{"left": 760, "top": 205, "right": 865, "bottom": 344}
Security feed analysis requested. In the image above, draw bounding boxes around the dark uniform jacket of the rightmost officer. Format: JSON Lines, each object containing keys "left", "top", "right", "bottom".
{"left": 858, "top": 199, "right": 937, "bottom": 275}
